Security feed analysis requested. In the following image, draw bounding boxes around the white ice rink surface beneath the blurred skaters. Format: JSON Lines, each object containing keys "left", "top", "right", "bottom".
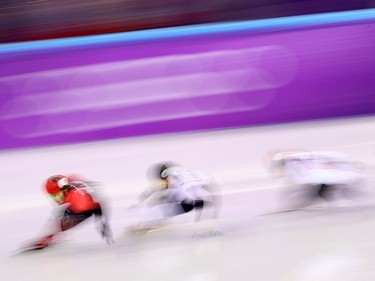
{"left": 0, "top": 114, "right": 375, "bottom": 281}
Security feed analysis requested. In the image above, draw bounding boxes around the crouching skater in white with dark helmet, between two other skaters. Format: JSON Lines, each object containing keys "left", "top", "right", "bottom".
{"left": 132, "top": 163, "right": 221, "bottom": 235}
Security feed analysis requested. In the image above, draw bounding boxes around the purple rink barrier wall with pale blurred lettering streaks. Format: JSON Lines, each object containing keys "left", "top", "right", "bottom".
{"left": 0, "top": 20, "right": 375, "bottom": 149}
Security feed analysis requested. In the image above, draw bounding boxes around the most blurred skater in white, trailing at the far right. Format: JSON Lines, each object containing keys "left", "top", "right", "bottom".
{"left": 265, "top": 150, "right": 363, "bottom": 209}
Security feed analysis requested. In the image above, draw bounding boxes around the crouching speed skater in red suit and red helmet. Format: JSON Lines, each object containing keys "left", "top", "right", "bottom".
{"left": 29, "top": 175, "right": 113, "bottom": 249}
